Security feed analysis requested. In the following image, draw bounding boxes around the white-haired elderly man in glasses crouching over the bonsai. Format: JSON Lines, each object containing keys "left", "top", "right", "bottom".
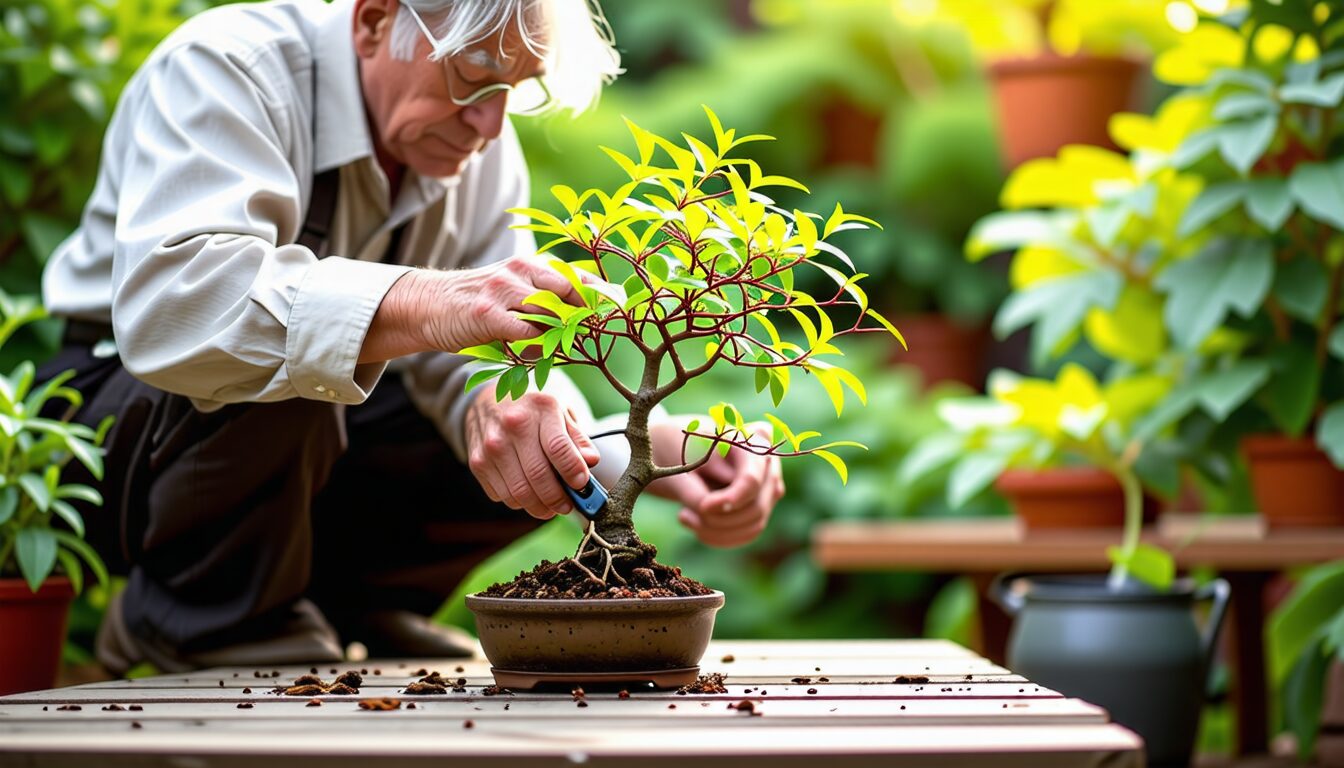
{"left": 43, "top": 0, "right": 782, "bottom": 674}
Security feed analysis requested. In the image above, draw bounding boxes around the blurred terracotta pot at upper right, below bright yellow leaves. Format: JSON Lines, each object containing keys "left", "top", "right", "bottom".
{"left": 989, "top": 54, "right": 1144, "bottom": 168}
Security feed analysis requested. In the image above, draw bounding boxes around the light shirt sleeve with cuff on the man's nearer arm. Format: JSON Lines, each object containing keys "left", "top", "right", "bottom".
{"left": 112, "top": 46, "right": 410, "bottom": 410}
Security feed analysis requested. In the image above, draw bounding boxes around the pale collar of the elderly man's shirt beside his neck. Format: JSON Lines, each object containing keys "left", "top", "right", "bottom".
{"left": 313, "top": 0, "right": 374, "bottom": 174}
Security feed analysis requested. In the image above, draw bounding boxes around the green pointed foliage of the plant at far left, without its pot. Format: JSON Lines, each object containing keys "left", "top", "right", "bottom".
{"left": 0, "top": 291, "right": 112, "bottom": 592}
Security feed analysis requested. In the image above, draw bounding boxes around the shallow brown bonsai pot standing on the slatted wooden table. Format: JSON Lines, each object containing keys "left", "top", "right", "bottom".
{"left": 466, "top": 592, "right": 723, "bottom": 689}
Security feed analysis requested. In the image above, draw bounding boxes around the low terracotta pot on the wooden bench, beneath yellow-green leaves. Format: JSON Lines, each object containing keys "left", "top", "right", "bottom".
{"left": 995, "top": 467, "right": 1125, "bottom": 529}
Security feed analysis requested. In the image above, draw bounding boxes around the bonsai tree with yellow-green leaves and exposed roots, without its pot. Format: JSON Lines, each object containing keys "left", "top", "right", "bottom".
{"left": 464, "top": 108, "right": 903, "bottom": 582}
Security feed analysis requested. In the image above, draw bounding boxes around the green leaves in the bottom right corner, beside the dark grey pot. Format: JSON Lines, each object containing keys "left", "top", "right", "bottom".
{"left": 1267, "top": 561, "right": 1344, "bottom": 765}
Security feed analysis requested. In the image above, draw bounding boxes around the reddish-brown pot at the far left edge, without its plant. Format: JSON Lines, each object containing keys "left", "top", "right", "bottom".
{"left": 0, "top": 576, "right": 75, "bottom": 695}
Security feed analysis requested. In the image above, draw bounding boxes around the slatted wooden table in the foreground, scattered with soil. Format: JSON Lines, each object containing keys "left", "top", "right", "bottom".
{"left": 0, "top": 640, "right": 1144, "bottom": 768}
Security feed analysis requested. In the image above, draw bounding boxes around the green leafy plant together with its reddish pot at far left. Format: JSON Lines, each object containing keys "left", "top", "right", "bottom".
{"left": 0, "top": 291, "right": 112, "bottom": 695}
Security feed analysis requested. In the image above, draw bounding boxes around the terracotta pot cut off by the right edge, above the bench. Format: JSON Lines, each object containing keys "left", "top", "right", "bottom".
{"left": 1242, "top": 434, "right": 1344, "bottom": 529}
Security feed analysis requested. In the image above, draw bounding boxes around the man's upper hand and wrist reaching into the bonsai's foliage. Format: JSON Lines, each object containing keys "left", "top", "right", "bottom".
{"left": 359, "top": 256, "right": 582, "bottom": 363}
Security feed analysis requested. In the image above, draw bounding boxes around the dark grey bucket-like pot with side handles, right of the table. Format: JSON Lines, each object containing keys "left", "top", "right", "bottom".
{"left": 991, "top": 574, "right": 1231, "bottom": 765}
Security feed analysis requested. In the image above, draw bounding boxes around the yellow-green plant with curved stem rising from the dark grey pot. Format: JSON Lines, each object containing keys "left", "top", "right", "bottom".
{"left": 899, "top": 363, "right": 1175, "bottom": 589}
